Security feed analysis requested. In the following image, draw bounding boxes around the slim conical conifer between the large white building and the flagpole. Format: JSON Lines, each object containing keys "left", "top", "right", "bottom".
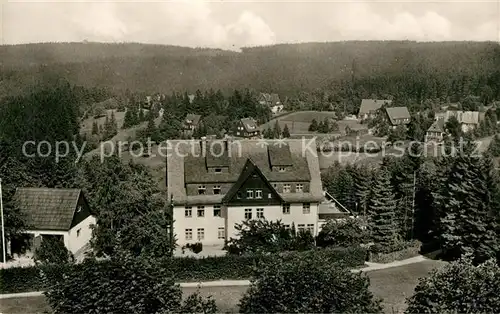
{"left": 368, "top": 168, "right": 397, "bottom": 252}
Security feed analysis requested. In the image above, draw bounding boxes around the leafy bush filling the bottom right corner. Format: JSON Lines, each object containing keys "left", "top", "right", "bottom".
{"left": 406, "top": 256, "right": 500, "bottom": 313}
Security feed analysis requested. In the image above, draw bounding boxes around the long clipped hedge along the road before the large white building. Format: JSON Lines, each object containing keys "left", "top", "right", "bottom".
{"left": 0, "top": 247, "right": 366, "bottom": 293}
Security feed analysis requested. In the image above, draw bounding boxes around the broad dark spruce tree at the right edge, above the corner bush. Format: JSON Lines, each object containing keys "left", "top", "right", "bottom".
{"left": 439, "top": 140, "right": 499, "bottom": 262}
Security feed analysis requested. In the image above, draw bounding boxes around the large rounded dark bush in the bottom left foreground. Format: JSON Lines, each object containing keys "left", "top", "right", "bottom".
{"left": 45, "top": 256, "right": 217, "bottom": 313}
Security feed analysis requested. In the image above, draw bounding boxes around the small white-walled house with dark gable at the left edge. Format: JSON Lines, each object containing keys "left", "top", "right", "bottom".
{"left": 14, "top": 188, "right": 96, "bottom": 254}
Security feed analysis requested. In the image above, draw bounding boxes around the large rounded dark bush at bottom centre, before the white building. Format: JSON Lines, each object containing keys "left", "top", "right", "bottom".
{"left": 239, "top": 257, "right": 382, "bottom": 313}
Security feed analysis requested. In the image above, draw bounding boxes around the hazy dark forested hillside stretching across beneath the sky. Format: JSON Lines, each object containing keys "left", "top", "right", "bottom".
{"left": 0, "top": 41, "right": 500, "bottom": 103}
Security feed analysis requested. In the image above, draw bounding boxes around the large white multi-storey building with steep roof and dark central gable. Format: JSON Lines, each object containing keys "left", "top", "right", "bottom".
{"left": 167, "top": 139, "right": 324, "bottom": 246}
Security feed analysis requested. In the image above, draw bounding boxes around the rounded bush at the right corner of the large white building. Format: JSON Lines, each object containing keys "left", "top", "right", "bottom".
{"left": 316, "top": 218, "right": 366, "bottom": 247}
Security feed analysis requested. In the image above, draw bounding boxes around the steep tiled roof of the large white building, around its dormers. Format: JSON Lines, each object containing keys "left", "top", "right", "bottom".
{"left": 166, "top": 139, "right": 324, "bottom": 206}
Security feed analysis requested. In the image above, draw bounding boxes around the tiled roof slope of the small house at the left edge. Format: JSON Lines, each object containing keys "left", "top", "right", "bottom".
{"left": 14, "top": 188, "right": 81, "bottom": 231}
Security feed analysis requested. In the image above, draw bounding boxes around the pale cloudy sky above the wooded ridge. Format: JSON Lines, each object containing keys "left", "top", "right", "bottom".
{"left": 0, "top": 0, "right": 500, "bottom": 48}
